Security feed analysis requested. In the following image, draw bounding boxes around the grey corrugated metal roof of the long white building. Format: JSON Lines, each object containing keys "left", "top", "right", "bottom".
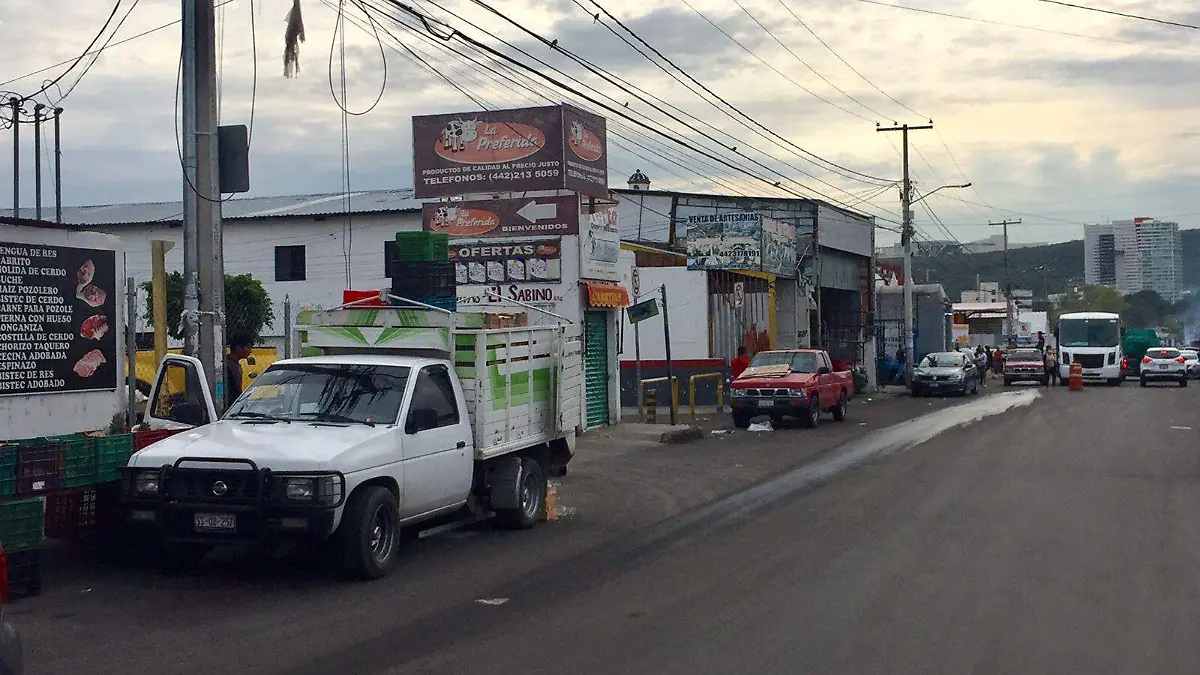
{"left": 20, "top": 189, "right": 421, "bottom": 226}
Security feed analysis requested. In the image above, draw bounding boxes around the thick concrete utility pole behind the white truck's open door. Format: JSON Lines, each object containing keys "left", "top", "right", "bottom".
{"left": 182, "top": 0, "right": 224, "bottom": 412}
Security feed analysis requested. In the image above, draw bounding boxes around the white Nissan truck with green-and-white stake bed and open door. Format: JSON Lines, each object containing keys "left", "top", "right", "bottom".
{"left": 122, "top": 302, "right": 583, "bottom": 579}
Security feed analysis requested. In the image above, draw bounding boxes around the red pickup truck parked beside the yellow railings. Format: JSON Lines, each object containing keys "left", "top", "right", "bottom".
{"left": 731, "top": 350, "right": 854, "bottom": 429}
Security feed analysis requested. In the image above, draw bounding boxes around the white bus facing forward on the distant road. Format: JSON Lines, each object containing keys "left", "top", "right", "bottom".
{"left": 1058, "top": 312, "right": 1124, "bottom": 387}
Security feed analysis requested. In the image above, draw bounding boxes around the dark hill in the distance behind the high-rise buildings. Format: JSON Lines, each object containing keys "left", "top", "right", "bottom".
{"left": 888, "top": 229, "right": 1200, "bottom": 301}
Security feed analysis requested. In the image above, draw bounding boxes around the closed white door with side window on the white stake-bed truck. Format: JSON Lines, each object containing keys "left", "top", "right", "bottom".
{"left": 401, "top": 364, "right": 475, "bottom": 518}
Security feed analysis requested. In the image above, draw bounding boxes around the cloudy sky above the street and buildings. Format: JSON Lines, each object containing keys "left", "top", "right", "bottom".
{"left": 0, "top": 0, "right": 1200, "bottom": 243}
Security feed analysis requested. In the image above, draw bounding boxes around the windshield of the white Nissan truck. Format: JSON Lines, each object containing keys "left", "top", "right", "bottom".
{"left": 226, "top": 364, "right": 409, "bottom": 424}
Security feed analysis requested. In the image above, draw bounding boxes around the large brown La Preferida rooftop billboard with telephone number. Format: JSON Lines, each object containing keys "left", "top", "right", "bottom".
{"left": 413, "top": 104, "right": 608, "bottom": 199}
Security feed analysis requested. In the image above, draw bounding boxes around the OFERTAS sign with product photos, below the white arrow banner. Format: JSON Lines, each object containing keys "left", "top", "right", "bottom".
{"left": 450, "top": 239, "right": 563, "bottom": 285}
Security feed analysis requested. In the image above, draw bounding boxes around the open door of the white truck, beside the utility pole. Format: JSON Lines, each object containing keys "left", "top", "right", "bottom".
{"left": 143, "top": 354, "right": 217, "bottom": 429}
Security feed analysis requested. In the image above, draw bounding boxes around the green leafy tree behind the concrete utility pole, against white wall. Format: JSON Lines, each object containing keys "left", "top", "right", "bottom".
{"left": 142, "top": 271, "right": 275, "bottom": 345}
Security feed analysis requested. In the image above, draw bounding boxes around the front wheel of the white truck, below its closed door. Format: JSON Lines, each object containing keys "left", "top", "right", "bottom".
{"left": 337, "top": 485, "right": 400, "bottom": 579}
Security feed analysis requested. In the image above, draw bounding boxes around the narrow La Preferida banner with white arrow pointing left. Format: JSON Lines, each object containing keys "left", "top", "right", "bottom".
{"left": 422, "top": 195, "right": 580, "bottom": 239}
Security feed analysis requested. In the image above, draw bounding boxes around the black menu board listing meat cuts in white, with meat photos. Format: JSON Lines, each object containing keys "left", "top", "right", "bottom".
{"left": 0, "top": 241, "right": 119, "bottom": 396}
